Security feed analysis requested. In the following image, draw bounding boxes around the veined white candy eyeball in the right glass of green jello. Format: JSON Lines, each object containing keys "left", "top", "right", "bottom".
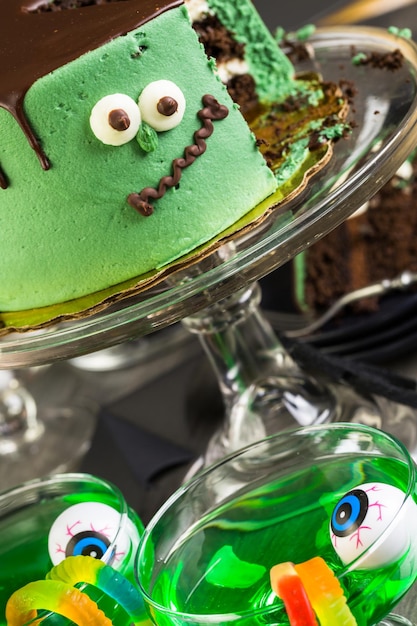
{"left": 330, "top": 482, "right": 417, "bottom": 569}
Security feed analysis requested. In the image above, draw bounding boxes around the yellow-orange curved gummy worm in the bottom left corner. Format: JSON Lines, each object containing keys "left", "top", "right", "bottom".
{"left": 6, "top": 580, "right": 112, "bottom": 626}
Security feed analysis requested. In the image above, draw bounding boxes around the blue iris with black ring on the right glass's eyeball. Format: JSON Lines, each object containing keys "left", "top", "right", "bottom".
{"left": 331, "top": 489, "right": 369, "bottom": 537}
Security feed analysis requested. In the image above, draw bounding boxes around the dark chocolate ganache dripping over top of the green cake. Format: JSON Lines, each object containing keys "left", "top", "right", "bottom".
{"left": 0, "top": 0, "right": 183, "bottom": 189}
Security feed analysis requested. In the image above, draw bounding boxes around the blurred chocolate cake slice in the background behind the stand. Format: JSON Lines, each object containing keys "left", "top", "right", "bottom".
{"left": 293, "top": 154, "right": 417, "bottom": 314}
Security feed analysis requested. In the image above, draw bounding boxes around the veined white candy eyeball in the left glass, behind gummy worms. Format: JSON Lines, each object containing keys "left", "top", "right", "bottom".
{"left": 48, "top": 502, "right": 139, "bottom": 569}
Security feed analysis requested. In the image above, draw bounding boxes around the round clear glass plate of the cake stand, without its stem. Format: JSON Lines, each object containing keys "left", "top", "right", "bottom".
{"left": 0, "top": 27, "right": 417, "bottom": 368}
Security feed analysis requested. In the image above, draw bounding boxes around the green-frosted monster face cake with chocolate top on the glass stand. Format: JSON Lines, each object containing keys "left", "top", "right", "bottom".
{"left": 0, "top": 0, "right": 343, "bottom": 328}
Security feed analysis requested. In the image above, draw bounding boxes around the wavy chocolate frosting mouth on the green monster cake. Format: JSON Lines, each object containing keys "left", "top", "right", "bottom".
{"left": 127, "top": 94, "right": 229, "bottom": 217}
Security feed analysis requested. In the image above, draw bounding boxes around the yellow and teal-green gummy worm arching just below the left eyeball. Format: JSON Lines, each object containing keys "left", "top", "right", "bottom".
{"left": 46, "top": 555, "right": 145, "bottom": 621}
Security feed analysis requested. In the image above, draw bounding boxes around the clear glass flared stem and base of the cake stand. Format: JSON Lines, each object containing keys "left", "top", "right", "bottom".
{"left": 183, "top": 283, "right": 388, "bottom": 479}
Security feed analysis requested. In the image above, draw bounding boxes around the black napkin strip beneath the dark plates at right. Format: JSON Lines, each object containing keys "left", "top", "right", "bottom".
{"left": 278, "top": 333, "right": 417, "bottom": 408}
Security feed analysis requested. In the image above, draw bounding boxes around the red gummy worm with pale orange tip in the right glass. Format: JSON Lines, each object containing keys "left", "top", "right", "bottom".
{"left": 270, "top": 563, "right": 318, "bottom": 626}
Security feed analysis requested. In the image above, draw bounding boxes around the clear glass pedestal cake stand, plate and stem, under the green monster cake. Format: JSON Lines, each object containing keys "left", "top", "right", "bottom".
{"left": 0, "top": 27, "right": 417, "bottom": 486}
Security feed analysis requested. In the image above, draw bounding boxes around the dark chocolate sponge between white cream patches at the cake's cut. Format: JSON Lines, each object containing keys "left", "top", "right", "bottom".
{"left": 193, "top": 15, "right": 245, "bottom": 63}
